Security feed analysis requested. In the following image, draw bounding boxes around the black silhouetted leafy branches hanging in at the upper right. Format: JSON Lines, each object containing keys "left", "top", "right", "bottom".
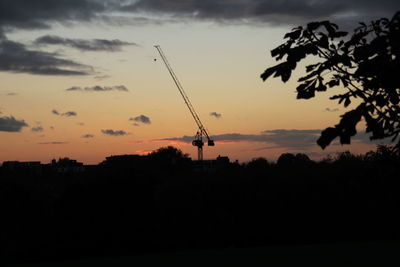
{"left": 261, "top": 12, "right": 400, "bottom": 152}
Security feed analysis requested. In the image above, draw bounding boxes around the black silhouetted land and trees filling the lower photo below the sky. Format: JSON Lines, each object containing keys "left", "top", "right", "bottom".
{"left": 0, "top": 147, "right": 400, "bottom": 266}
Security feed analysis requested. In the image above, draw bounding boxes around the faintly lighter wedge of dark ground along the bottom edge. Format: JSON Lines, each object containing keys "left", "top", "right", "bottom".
{"left": 5, "top": 242, "right": 400, "bottom": 267}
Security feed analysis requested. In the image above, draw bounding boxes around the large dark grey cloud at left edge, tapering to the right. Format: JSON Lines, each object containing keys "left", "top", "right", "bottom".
{"left": 0, "top": 39, "right": 93, "bottom": 76}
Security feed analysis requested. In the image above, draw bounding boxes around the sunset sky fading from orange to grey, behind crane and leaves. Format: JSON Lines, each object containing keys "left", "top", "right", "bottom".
{"left": 0, "top": 0, "right": 400, "bottom": 164}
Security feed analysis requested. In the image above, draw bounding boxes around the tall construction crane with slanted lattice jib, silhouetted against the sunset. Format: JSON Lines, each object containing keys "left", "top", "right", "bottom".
{"left": 154, "top": 45, "right": 215, "bottom": 161}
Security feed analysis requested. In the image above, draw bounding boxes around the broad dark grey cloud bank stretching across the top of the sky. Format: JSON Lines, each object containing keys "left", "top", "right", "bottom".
{"left": 0, "top": 0, "right": 400, "bottom": 34}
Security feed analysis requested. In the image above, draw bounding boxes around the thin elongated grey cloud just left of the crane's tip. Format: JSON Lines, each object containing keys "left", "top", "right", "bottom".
{"left": 35, "top": 35, "right": 137, "bottom": 52}
